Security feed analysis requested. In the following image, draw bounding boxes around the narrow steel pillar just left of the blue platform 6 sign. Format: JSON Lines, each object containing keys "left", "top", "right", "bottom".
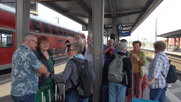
{"left": 112, "top": 17, "right": 119, "bottom": 44}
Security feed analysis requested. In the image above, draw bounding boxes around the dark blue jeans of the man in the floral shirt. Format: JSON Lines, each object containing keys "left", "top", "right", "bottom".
{"left": 11, "top": 93, "right": 35, "bottom": 102}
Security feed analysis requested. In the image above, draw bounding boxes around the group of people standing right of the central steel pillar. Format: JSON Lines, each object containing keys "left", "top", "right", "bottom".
{"left": 102, "top": 39, "right": 170, "bottom": 102}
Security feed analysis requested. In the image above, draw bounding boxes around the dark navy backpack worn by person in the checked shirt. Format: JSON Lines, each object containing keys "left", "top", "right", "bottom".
{"left": 161, "top": 55, "right": 177, "bottom": 83}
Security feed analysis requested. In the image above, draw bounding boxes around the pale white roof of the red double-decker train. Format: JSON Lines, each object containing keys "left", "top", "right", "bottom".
{"left": 0, "top": 4, "right": 82, "bottom": 33}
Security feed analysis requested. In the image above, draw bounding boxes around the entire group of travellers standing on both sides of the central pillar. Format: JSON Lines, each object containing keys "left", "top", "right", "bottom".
{"left": 11, "top": 34, "right": 170, "bottom": 102}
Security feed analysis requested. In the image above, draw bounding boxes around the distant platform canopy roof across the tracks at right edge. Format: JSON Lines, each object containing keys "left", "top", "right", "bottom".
{"left": 157, "top": 29, "right": 181, "bottom": 38}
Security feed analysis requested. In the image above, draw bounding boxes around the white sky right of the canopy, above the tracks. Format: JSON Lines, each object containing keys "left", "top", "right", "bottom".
{"left": 124, "top": 0, "right": 181, "bottom": 42}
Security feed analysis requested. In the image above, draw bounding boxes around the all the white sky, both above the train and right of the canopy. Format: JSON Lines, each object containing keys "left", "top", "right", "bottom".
{"left": 38, "top": 0, "right": 181, "bottom": 42}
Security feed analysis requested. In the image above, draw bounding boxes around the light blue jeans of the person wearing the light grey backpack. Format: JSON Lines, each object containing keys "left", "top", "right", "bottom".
{"left": 108, "top": 82, "right": 126, "bottom": 102}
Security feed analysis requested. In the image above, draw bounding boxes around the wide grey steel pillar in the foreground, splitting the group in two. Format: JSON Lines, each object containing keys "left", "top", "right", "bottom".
{"left": 92, "top": 0, "right": 104, "bottom": 102}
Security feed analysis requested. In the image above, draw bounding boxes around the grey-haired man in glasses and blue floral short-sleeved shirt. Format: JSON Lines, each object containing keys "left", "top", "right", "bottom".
{"left": 11, "top": 34, "right": 49, "bottom": 102}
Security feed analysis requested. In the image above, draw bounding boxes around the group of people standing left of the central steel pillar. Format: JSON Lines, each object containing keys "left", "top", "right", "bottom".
{"left": 11, "top": 34, "right": 95, "bottom": 102}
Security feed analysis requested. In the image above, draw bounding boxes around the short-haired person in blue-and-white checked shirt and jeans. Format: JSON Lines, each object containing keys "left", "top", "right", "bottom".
{"left": 147, "top": 41, "right": 170, "bottom": 102}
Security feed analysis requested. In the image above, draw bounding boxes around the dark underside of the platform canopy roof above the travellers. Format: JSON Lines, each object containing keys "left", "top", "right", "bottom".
{"left": 36, "top": 0, "right": 163, "bottom": 32}
